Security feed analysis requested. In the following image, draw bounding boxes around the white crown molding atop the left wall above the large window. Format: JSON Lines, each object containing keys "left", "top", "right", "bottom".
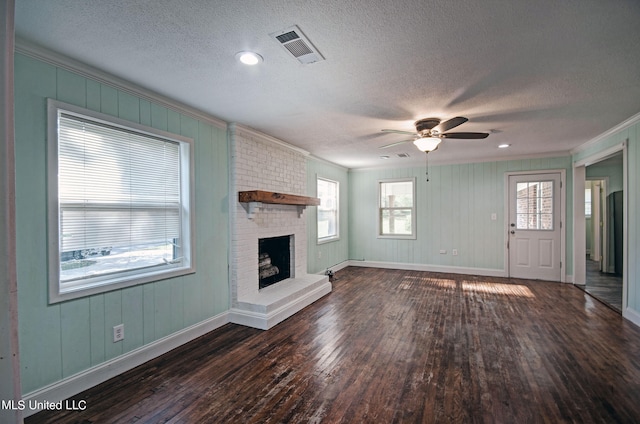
{"left": 15, "top": 37, "right": 227, "bottom": 129}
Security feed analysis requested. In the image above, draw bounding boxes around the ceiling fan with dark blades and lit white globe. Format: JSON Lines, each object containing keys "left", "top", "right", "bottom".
{"left": 380, "top": 116, "right": 489, "bottom": 153}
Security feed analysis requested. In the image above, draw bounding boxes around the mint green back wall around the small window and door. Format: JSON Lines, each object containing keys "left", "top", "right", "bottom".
{"left": 349, "top": 157, "right": 573, "bottom": 273}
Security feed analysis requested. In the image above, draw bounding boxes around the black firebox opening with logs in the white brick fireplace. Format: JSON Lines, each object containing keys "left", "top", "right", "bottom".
{"left": 258, "top": 235, "right": 293, "bottom": 289}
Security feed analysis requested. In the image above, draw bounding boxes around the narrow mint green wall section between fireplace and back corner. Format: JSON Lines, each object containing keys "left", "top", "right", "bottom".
{"left": 305, "top": 158, "right": 349, "bottom": 274}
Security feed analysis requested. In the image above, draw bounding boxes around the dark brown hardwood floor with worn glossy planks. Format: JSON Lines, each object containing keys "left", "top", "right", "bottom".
{"left": 26, "top": 267, "right": 640, "bottom": 424}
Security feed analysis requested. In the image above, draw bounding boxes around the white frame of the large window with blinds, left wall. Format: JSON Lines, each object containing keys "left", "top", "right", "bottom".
{"left": 47, "top": 99, "right": 195, "bottom": 303}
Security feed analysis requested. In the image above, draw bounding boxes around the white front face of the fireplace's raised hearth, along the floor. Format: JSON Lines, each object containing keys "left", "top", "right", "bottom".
{"left": 229, "top": 279, "right": 333, "bottom": 330}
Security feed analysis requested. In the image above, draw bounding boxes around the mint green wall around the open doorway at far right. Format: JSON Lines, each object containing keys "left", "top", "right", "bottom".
{"left": 572, "top": 124, "right": 640, "bottom": 314}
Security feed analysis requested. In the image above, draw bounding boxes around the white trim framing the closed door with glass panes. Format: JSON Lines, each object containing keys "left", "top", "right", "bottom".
{"left": 503, "top": 169, "right": 568, "bottom": 283}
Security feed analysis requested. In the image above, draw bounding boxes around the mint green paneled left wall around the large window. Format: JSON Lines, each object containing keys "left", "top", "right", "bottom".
{"left": 15, "top": 54, "right": 229, "bottom": 393}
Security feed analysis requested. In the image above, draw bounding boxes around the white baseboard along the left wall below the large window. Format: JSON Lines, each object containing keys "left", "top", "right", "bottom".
{"left": 23, "top": 312, "right": 229, "bottom": 417}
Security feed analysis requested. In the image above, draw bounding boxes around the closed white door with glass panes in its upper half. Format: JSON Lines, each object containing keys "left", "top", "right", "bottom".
{"left": 508, "top": 173, "right": 562, "bottom": 281}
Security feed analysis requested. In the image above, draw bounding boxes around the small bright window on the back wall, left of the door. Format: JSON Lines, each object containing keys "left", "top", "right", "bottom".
{"left": 378, "top": 178, "right": 416, "bottom": 239}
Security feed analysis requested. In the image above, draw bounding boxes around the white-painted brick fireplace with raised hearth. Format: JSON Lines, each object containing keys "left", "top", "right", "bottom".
{"left": 228, "top": 124, "right": 331, "bottom": 329}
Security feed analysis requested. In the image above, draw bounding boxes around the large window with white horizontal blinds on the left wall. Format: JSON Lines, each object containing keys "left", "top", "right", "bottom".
{"left": 48, "top": 101, "right": 193, "bottom": 302}
